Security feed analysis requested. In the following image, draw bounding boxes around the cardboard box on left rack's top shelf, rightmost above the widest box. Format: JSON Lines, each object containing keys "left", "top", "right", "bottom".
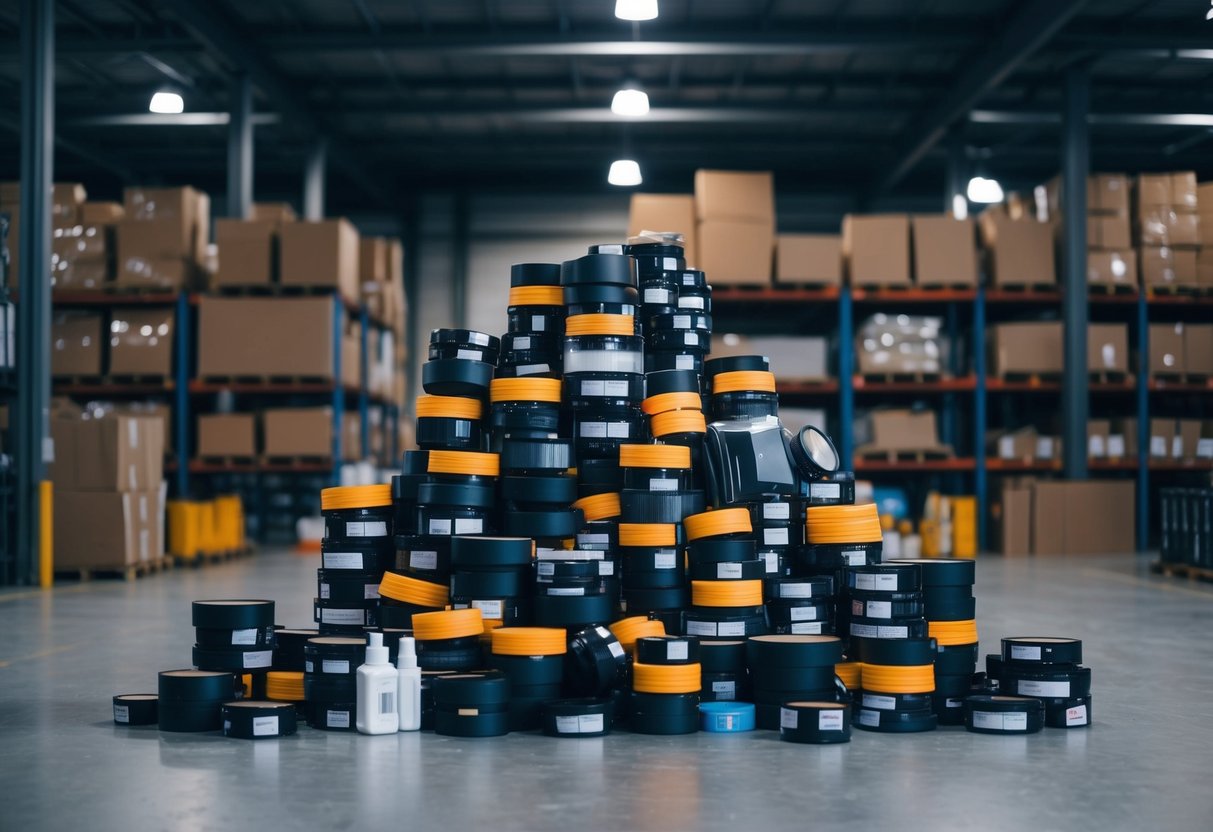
{"left": 278, "top": 218, "right": 359, "bottom": 301}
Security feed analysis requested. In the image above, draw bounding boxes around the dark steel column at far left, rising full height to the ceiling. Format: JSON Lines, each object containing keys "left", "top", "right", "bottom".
{"left": 11, "top": 0, "right": 55, "bottom": 583}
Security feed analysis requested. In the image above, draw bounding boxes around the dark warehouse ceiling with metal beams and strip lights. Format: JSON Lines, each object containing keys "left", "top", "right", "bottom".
{"left": 0, "top": 0, "right": 1213, "bottom": 210}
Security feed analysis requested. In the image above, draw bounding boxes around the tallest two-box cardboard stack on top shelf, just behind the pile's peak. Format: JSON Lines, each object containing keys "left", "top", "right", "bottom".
{"left": 695, "top": 170, "right": 775, "bottom": 286}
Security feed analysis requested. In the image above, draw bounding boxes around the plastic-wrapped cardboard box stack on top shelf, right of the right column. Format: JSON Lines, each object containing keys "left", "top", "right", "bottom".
{"left": 1133, "top": 171, "right": 1201, "bottom": 289}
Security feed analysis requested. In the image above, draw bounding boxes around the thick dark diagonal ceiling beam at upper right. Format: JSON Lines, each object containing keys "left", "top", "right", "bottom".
{"left": 872, "top": 0, "right": 1086, "bottom": 195}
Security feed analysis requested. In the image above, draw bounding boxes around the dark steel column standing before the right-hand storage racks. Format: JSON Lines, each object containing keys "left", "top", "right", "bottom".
{"left": 1061, "top": 65, "right": 1090, "bottom": 479}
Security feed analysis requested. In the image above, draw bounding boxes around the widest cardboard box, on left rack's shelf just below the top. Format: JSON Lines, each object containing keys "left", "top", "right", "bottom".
{"left": 198, "top": 296, "right": 334, "bottom": 380}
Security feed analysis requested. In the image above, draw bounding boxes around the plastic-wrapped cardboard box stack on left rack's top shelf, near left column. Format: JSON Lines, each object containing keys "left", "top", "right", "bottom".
{"left": 114, "top": 187, "right": 211, "bottom": 291}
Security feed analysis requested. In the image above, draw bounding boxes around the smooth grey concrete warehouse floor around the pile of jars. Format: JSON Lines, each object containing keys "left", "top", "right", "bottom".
{"left": 0, "top": 553, "right": 1213, "bottom": 832}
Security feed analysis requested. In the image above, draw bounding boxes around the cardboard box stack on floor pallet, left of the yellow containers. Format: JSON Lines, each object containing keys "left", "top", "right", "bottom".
{"left": 47, "top": 414, "right": 165, "bottom": 569}
